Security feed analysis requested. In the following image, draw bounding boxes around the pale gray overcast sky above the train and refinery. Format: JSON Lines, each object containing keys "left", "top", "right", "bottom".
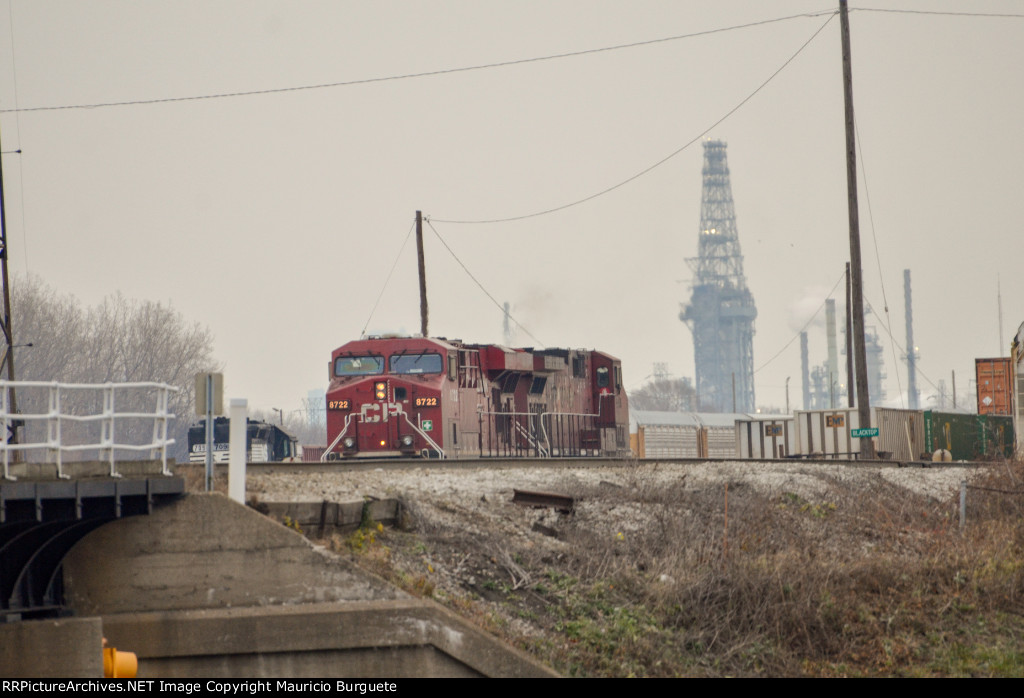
{"left": 0, "top": 0, "right": 1024, "bottom": 419}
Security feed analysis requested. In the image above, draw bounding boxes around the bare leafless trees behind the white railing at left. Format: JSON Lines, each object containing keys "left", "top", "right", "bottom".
{"left": 11, "top": 277, "right": 218, "bottom": 459}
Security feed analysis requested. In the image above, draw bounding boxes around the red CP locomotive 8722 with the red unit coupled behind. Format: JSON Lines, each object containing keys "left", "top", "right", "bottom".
{"left": 323, "top": 337, "right": 629, "bottom": 461}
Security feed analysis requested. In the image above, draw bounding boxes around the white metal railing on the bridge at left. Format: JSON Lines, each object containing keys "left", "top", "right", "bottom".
{"left": 0, "top": 380, "right": 179, "bottom": 480}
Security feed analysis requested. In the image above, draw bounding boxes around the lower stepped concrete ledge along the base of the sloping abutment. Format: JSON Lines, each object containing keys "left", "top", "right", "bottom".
{"left": 103, "top": 599, "right": 551, "bottom": 679}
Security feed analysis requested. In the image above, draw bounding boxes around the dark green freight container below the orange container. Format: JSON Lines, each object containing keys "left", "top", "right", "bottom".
{"left": 925, "top": 410, "right": 1014, "bottom": 461}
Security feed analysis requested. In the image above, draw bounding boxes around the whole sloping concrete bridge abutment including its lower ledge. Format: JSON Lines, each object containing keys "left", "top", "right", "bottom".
{"left": 65, "top": 494, "right": 554, "bottom": 678}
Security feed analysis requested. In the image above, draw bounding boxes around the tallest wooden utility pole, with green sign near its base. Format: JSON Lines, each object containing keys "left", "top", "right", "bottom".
{"left": 839, "top": 0, "right": 874, "bottom": 461}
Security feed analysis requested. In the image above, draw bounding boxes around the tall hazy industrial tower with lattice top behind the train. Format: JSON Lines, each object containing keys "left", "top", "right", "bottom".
{"left": 679, "top": 140, "right": 758, "bottom": 412}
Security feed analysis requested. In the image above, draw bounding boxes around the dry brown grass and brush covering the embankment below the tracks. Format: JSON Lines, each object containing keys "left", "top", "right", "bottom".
{"left": 339, "top": 456, "right": 1024, "bottom": 677}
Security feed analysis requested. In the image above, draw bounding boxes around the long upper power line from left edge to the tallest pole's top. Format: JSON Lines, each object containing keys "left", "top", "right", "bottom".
{"left": 0, "top": 10, "right": 835, "bottom": 114}
